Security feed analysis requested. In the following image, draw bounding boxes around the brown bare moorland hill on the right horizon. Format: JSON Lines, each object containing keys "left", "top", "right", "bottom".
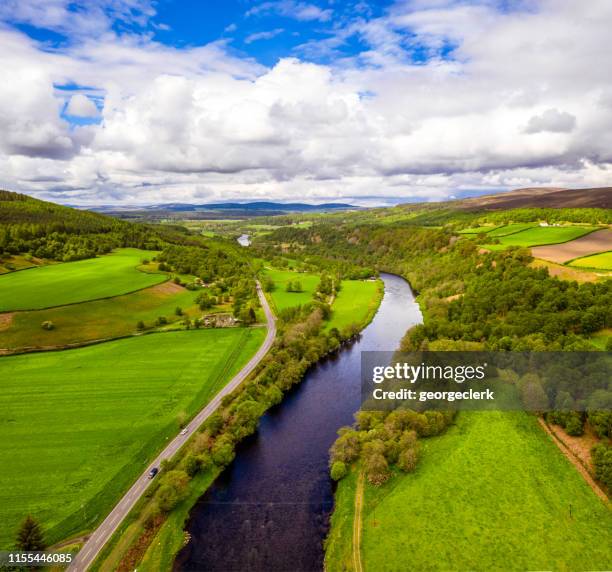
{"left": 456, "top": 187, "right": 612, "bottom": 210}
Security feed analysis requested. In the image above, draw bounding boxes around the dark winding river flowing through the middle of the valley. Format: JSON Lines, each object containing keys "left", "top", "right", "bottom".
{"left": 174, "top": 274, "right": 422, "bottom": 572}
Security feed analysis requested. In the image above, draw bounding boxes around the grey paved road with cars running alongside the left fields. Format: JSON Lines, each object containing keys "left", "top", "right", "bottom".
{"left": 68, "top": 282, "right": 276, "bottom": 572}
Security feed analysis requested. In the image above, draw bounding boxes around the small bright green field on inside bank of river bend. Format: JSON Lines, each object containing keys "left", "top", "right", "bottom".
{"left": 326, "top": 280, "right": 383, "bottom": 331}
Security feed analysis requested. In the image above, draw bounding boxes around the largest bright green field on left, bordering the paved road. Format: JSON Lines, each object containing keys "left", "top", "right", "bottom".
{"left": 0, "top": 328, "right": 265, "bottom": 549}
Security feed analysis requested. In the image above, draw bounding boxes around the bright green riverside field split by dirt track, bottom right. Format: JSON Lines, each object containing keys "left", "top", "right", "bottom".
{"left": 326, "top": 411, "right": 612, "bottom": 572}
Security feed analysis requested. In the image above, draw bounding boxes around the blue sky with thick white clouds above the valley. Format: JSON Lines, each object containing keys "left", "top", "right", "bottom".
{"left": 0, "top": 0, "right": 612, "bottom": 205}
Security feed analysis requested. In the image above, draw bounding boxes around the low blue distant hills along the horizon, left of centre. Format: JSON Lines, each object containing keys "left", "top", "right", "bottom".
{"left": 88, "top": 201, "right": 360, "bottom": 220}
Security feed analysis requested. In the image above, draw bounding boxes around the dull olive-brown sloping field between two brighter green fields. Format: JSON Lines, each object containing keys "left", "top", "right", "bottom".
{"left": 0, "top": 282, "right": 213, "bottom": 349}
